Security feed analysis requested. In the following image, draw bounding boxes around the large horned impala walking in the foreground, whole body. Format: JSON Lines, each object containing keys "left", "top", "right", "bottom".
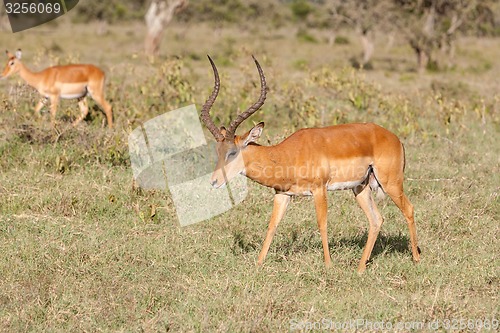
{"left": 201, "top": 57, "right": 420, "bottom": 272}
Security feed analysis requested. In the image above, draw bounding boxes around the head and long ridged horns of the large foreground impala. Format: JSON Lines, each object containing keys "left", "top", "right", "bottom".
{"left": 201, "top": 56, "right": 266, "bottom": 188}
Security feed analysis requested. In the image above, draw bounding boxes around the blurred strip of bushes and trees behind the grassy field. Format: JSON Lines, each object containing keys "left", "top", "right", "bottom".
{"left": 71, "top": 0, "right": 500, "bottom": 72}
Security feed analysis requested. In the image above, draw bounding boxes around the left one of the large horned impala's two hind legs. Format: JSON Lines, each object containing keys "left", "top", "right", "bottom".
{"left": 354, "top": 185, "right": 384, "bottom": 273}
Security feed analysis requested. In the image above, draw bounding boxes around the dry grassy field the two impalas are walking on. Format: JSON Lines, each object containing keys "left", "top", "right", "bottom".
{"left": 0, "top": 16, "right": 500, "bottom": 332}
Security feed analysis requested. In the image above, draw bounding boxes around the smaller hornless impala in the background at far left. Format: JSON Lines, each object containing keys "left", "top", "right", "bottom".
{"left": 1, "top": 49, "right": 113, "bottom": 128}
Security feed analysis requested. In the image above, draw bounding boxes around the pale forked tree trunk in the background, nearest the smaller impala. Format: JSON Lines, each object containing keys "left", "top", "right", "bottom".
{"left": 144, "top": 0, "right": 187, "bottom": 56}
